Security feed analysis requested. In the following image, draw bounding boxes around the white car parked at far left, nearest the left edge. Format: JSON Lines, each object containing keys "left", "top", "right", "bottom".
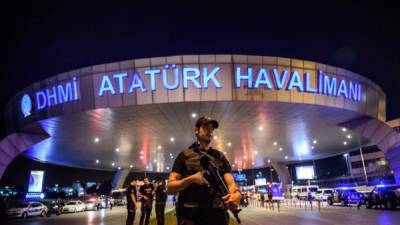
{"left": 6, "top": 202, "right": 48, "bottom": 218}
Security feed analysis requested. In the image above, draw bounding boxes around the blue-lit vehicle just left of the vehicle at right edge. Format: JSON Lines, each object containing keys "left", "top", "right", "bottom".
{"left": 327, "top": 187, "right": 364, "bottom": 206}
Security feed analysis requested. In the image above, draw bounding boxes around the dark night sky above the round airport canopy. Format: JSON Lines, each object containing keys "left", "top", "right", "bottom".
{"left": 0, "top": 1, "right": 400, "bottom": 183}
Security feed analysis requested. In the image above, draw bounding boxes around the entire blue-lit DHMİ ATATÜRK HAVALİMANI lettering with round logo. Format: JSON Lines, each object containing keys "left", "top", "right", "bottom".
{"left": 20, "top": 64, "right": 363, "bottom": 118}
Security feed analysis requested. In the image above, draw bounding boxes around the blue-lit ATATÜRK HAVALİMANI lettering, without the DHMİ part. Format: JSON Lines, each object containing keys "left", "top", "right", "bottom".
{"left": 97, "top": 64, "right": 362, "bottom": 101}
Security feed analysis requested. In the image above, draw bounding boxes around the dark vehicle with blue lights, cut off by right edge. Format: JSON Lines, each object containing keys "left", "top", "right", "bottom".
{"left": 365, "top": 185, "right": 400, "bottom": 209}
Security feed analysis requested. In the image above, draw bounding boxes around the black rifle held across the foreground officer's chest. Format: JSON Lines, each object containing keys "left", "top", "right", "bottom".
{"left": 199, "top": 151, "right": 242, "bottom": 224}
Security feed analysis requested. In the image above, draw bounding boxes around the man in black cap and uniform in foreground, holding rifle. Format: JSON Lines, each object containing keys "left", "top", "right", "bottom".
{"left": 167, "top": 117, "right": 241, "bottom": 225}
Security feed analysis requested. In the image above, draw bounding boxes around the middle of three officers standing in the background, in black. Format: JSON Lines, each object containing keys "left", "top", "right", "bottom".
{"left": 139, "top": 177, "right": 154, "bottom": 225}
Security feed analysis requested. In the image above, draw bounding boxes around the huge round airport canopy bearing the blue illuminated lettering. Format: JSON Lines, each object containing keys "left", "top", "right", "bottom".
{"left": 0, "top": 55, "right": 400, "bottom": 187}
